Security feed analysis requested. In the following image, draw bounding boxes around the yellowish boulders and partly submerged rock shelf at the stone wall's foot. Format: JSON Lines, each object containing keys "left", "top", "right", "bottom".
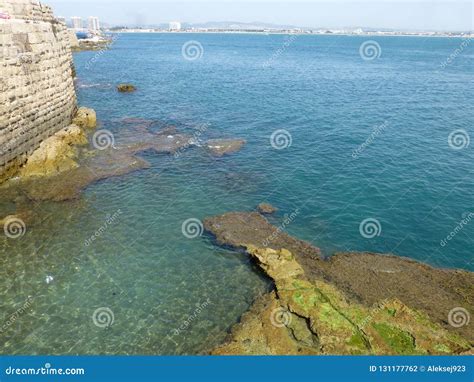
{"left": 0, "top": 113, "right": 248, "bottom": 231}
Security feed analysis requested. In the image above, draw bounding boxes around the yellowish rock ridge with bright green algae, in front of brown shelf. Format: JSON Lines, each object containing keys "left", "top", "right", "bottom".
{"left": 212, "top": 246, "right": 470, "bottom": 355}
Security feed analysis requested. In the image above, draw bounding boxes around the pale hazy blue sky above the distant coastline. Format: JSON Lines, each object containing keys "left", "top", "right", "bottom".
{"left": 43, "top": 0, "right": 474, "bottom": 30}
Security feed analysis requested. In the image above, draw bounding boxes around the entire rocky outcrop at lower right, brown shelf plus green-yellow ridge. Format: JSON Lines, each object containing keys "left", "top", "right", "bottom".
{"left": 204, "top": 212, "right": 474, "bottom": 355}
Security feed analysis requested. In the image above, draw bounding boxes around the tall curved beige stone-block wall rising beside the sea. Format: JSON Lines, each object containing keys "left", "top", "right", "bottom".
{"left": 0, "top": 0, "right": 77, "bottom": 182}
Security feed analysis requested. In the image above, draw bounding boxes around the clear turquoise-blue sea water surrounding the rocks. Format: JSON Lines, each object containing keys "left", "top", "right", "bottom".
{"left": 0, "top": 34, "right": 474, "bottom": 354}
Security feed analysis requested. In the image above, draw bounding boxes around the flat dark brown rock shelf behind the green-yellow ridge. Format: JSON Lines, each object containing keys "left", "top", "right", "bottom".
{"left": 204, "top": 212, "right": 474, "bottom": 345}
